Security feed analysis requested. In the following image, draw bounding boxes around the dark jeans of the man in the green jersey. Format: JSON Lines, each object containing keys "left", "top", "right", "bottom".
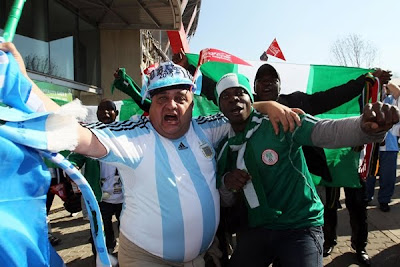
{"left": 229, "top": 226, "right": 324, "bottom": 267}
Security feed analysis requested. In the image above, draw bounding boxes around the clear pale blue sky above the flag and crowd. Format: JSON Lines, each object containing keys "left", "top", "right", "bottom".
{"left": 189, "top": 0, "right": 400, "bottom": 77}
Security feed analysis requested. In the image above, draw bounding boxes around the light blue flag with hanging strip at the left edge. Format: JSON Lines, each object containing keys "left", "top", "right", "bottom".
{"left": 0, "top": 45, "right": 111, "bottom": 267}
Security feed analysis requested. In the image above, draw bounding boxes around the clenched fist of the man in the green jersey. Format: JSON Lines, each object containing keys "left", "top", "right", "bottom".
{"left": 361, "top": 102, "right": 400, "bottom": 134}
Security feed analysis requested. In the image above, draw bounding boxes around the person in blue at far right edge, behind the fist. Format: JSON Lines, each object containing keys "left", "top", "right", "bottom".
{"left": 367, "top": 82, "right": 400, "bottom": 212}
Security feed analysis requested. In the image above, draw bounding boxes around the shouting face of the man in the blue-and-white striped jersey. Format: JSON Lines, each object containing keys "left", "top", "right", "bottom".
{"left": 149, "top": 89, "right": 193, "bottom": 139}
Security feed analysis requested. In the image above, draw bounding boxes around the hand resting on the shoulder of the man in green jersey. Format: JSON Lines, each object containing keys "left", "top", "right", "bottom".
{"left": 253, "top": 101, "right": 304, "bottom": 134}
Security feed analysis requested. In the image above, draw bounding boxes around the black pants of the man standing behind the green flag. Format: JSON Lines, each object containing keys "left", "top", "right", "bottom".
{"left": 324, "top": 181, "right": 368, "bottom": 251}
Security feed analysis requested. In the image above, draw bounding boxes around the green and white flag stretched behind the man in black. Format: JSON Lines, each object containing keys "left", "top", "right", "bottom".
{"left": 238, "top": 61, "right": 369, "bottom": 187}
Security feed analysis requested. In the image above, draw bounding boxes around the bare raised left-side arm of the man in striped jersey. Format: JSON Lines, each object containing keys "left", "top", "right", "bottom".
{"left": 0, "top": 43, "right": 107, "bottom": 158}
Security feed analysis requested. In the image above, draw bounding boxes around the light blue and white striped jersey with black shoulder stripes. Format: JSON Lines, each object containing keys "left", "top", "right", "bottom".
{"left": 87, "top": 116, "right": 230, "bottom": 262}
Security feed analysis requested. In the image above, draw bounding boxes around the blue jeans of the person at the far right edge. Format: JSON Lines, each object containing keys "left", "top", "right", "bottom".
{"left": 367, "top": 151, "right": 398, "bottom": 203}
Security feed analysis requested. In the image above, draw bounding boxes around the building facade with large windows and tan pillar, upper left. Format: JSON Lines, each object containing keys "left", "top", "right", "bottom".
{"left": 0, "top": 0, "right": 200, "bottom": 105}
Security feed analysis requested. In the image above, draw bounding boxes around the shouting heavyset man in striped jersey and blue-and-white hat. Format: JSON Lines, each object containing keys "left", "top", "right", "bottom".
{"left": 0, "top": 43, "right": 298, "bottom": 266}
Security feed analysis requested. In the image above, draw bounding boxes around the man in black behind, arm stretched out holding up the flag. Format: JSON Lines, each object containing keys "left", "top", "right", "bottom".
{"left": 254, "top": 64, "right": 392, "bottom": 265}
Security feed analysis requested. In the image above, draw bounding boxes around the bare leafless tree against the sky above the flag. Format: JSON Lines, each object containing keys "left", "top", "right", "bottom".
{"left": 331, "top": 34, "right": 377, "bottom": 68}
